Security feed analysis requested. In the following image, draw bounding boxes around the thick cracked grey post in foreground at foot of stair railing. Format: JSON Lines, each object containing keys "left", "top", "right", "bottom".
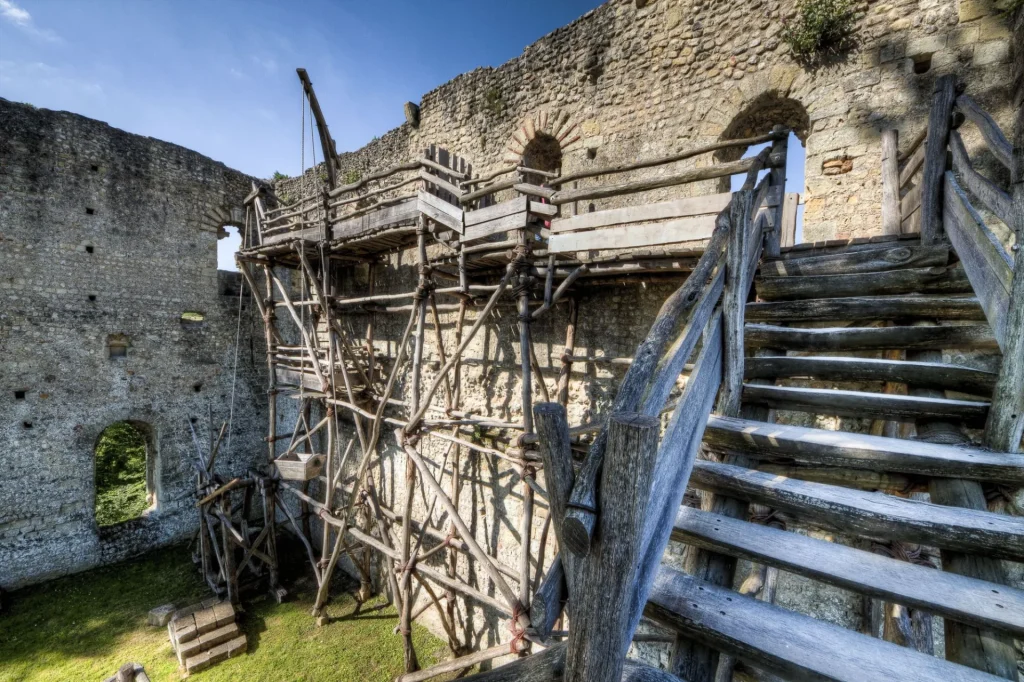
{"left": 565, "top": 413, "right": 659, "bottom": 682}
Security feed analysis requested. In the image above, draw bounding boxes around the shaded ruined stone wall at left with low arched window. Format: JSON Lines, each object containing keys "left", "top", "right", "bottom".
{"left": 0, "top": 99, "right": 266, "bottom": 589}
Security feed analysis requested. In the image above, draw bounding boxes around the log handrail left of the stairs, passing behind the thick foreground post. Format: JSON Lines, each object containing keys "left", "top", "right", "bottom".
{"left": 562, "top": 216, "right": 729, "bottom": 555}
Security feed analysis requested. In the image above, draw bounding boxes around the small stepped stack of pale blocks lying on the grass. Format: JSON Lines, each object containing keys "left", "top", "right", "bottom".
{"left": 167, "top": 598, "right": 248, "bottom": 673}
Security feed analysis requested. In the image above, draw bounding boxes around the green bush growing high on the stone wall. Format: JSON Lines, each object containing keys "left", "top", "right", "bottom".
{"left": 779, "top": 0, "right": 856, "bottom": 61}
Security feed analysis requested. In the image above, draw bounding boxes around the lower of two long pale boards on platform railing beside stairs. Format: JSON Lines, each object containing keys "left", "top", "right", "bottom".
{"left": 548, "top": 215, "right": 718, "bottom": 253}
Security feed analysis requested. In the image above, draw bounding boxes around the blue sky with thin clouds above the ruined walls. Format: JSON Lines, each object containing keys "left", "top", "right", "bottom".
{"left": 0, "top": 0, "right": 601, "bottom": 177}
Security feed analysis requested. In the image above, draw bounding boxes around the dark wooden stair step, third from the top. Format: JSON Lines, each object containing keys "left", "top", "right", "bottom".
{"left": 745, "top": 295, "right": 986, "bottom": 323}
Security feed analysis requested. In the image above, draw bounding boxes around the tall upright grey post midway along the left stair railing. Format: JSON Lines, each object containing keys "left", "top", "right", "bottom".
{"left": 718, "top": 189, "right": 752, "bottom": 417}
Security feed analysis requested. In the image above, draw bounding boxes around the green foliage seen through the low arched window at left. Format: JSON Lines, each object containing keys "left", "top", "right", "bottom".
{"left": 96, "top": 422, "right": 150, "bottom": 525}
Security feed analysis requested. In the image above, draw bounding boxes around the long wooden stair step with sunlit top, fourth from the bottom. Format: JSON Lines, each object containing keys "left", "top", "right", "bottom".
{"left": 703, "top": 415, "right": 1024, "bottom": 485}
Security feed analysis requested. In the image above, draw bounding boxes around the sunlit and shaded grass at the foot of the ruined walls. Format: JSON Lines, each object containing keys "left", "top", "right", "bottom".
{"left": 0, "top": 546, "right": 446, "bottom": 682}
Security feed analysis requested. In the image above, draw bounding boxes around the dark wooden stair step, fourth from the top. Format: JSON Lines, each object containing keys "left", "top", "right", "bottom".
{"left": 743, "top": 324, "right": 998, "bottom": 351}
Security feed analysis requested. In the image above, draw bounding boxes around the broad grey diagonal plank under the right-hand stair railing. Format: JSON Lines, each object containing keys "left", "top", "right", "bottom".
{"left": 942, "top": 172, "right": 1013, "bottom": 346}
